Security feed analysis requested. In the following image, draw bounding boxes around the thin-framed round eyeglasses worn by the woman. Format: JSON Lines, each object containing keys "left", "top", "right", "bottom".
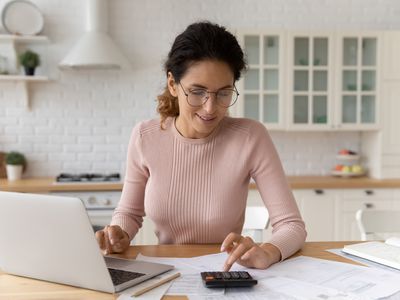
{"left": 179, "top": 82, "right": 239, "bottom": 107}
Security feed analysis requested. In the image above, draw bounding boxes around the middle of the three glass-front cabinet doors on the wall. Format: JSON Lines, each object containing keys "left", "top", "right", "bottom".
{"left": 287, "top": 34, "right": 333, "bottom": 130}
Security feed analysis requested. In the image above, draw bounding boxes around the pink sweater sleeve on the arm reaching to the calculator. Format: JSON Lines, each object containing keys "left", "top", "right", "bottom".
{"left": 249, "top": 122, "right": 307, "bottom": 260}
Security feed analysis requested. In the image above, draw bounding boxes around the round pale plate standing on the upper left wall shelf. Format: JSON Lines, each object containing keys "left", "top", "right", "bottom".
{"left": 1, "top": 0, "right": 44, "bottom": 35}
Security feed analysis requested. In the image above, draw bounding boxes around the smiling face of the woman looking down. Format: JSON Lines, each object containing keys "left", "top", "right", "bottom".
{"left": 168, "top": 60, "right": 234, "bottom": 139}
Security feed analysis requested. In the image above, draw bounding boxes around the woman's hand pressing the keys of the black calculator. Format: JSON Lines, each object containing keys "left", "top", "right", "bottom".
{"left": 221, "top": 232, "right": 281, "bottom": 272}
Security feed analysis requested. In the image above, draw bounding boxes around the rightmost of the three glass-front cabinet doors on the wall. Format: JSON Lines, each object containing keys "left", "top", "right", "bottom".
{"left": 337, "top": 35, "right": 378, "bottom": 129}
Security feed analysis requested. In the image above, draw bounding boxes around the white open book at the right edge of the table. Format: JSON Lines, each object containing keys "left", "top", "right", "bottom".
{"left": 342, "top": 238, "right": 400, "bottom": 270}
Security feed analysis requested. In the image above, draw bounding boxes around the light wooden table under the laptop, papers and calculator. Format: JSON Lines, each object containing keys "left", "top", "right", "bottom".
{"left": 0, "top": 242, "right": 360, "bottom": 300}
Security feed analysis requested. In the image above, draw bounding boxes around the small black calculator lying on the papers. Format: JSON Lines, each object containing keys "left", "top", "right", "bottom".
{"left": 200, "top": 271, "right": 257, "bottom": 288}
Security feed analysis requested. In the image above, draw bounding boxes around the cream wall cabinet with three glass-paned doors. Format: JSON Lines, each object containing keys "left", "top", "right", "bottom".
{"left": 235, "top": 31, "right": 381, "bottom": 130}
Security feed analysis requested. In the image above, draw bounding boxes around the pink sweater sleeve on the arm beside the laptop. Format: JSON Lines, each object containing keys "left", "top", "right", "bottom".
{"left": 111, "top": 124, "right": 149, "bottom": 239}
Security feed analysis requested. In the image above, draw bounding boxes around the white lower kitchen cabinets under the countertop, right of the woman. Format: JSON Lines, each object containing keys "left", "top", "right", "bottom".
{"left": 247, "top": 189, "right": 400, "bottom": 241}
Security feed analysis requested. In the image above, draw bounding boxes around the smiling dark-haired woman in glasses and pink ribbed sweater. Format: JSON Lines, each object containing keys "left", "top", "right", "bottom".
{"left": 96, "top": 22, "right": 306, "bottom": 271}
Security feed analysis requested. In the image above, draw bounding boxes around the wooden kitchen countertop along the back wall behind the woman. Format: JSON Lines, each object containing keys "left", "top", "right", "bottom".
{"left": 0, "top": 176, "right": 400, "bottom": 193}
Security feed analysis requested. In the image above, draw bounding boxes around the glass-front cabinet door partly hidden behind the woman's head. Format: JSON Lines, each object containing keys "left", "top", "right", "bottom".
{"left": 237, "top": 33, "right": 284, "bottom": 129}
